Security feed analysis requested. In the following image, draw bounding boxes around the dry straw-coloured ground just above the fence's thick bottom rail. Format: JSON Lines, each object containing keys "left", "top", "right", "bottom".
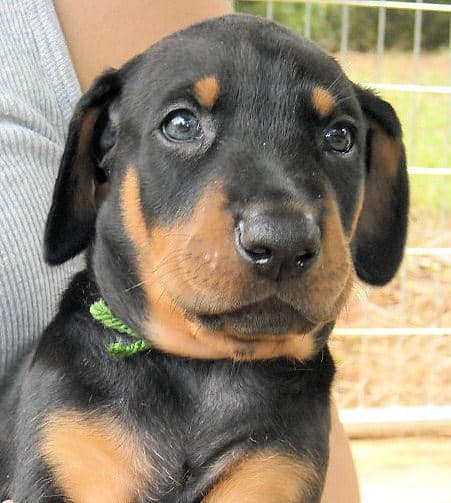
{"left": 331, "top": 335, "right": 451, "bottom": 408}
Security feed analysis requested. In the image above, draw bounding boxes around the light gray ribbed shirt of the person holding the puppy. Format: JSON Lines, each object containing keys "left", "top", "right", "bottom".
{"left": 0, "top": 0, "right": 81, "bottom": 381}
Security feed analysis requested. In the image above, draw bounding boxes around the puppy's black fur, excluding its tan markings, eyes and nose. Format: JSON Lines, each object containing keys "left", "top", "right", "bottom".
{"left": 0, "top": 15, "right": 408, "bottom": 503}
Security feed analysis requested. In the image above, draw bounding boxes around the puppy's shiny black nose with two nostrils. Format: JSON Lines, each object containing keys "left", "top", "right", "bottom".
{"left": 236, "top": 213, "right": 321, "bottom": 279}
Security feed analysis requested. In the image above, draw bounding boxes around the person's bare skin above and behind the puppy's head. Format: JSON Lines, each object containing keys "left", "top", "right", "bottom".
{"left": 54, "top": 0, "right": 233, "bottom": 91}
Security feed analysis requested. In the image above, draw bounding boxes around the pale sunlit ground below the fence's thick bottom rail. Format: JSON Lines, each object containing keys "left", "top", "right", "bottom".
{"left": 354, "top": 437, "right": 451, "bottom": 503}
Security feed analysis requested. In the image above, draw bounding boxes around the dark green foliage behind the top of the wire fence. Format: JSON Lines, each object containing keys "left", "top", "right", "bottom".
{"left": 235, "top": 0, "right": 449, "bottom": 52}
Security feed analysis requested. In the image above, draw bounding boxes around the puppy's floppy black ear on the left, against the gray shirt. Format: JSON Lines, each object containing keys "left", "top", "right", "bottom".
{"left": 44, "top": 70, "right": 121, "bottom": 265}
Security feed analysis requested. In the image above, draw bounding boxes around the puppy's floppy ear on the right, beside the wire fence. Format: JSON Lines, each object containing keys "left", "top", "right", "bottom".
{"left": 353, "top": 86, "right": 409, "bottom": 285}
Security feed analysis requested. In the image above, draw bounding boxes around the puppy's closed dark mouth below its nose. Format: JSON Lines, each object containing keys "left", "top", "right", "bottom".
{"left": 195, "top": 297, "right": 316, "bottom": 340}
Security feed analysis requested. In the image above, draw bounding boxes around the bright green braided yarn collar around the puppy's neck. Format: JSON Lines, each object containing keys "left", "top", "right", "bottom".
{"left": 89, "top": 299, "right": 152, "bottom": 357}
